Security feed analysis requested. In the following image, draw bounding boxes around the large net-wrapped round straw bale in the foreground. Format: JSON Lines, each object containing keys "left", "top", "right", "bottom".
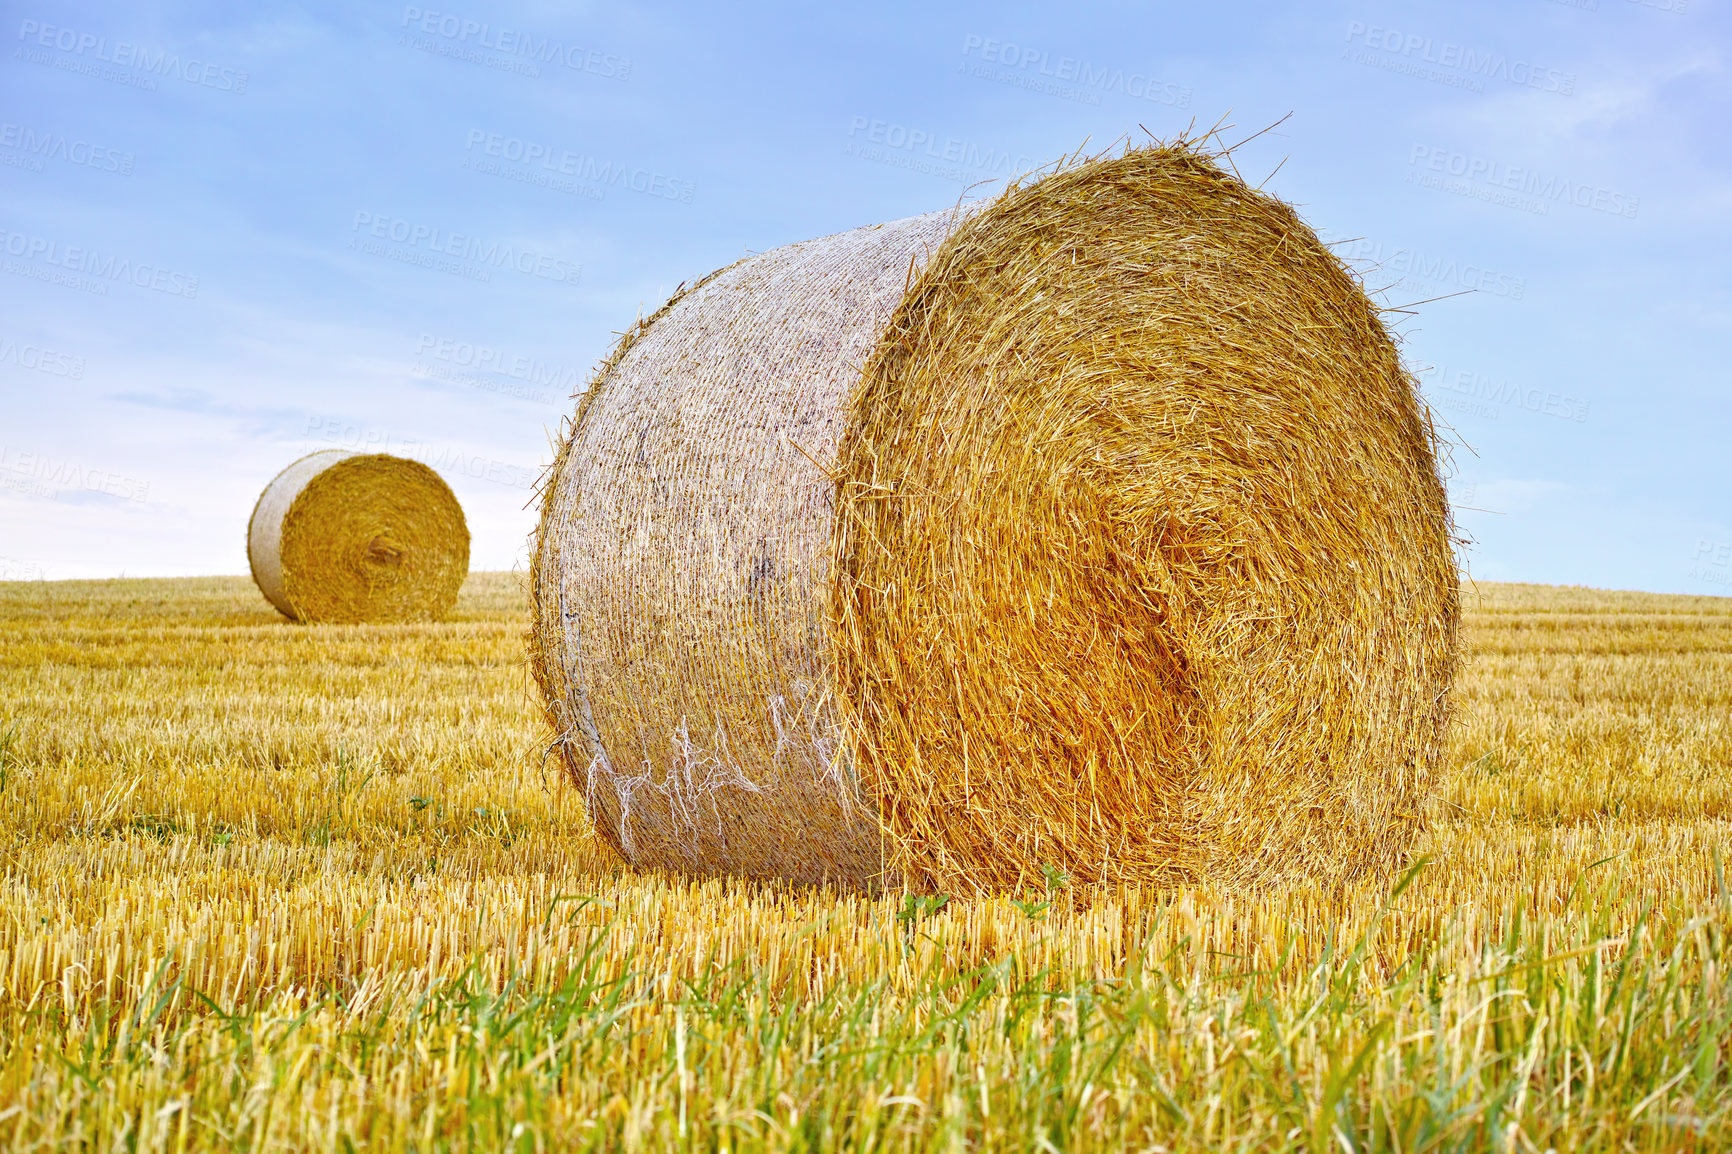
{"left": 532, "top": 142, "right": 1458, "bottom": 892}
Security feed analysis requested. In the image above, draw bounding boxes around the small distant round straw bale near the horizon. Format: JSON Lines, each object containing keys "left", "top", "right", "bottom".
{"left": 246, "top": 449, "right": 469, "bottom": 624}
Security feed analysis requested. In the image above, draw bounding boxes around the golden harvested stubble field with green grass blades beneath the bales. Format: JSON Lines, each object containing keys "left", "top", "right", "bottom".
{"left": 0, "top": 574, "right": 1732, "bottom": 1152}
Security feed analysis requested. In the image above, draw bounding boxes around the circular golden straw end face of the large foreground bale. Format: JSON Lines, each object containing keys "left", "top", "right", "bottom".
{"left": 830, "top": 151, "right": 1458, "bottom": 889}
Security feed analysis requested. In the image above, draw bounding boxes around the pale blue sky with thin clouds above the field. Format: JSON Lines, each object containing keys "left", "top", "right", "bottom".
{"left": 0, "top": 0, "right": 1732, "bottom": 594}
